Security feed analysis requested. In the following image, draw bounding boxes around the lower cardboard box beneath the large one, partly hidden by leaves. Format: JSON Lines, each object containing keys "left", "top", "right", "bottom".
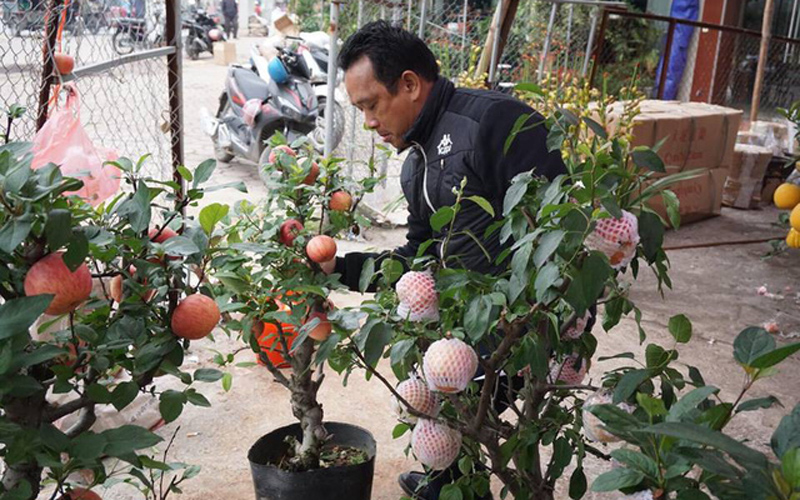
{"left": 649, "top": 167, "right": 728, "bottom": 224}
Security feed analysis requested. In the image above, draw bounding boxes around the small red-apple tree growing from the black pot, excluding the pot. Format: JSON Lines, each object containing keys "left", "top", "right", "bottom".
{"left": 206, "top": 135, "right": 380, "bottom": 471}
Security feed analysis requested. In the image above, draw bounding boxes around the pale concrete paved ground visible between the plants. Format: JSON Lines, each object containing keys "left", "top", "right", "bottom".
{"left": 17, "top": 36, "right": 800, "bottom": 500}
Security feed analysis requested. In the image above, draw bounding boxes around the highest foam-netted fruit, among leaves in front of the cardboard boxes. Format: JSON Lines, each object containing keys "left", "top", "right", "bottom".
{"left": 585, "top": 210, "right": 639, "bottom": 269}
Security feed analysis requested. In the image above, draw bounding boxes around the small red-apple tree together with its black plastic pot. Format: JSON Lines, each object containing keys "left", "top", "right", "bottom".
{"left": 205, "top": 135, "right": 380, "bottom": 499}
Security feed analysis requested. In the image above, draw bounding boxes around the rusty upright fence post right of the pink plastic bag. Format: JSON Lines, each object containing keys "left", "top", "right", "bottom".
{"left": 166, "top": 0, "right": 184, "bottom": 203}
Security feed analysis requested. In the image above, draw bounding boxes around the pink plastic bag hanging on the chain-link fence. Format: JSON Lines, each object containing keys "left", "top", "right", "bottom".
{"left": 31, "top": 85, "right": 120, "bottom": 207}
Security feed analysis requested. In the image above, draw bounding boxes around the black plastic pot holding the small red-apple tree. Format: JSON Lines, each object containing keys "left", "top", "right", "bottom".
{"left": 247, "top": 422, "right": 376, "bottom": 500}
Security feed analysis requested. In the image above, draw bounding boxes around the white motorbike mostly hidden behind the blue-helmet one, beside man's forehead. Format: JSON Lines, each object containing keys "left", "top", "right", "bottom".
{"left": 250, "top": 35, "right": 345, "bottom": 151}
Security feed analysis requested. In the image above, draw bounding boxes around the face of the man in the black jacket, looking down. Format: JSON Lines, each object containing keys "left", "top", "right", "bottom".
{"left": 344, "top": 56, "right": 424, "bottom": 149}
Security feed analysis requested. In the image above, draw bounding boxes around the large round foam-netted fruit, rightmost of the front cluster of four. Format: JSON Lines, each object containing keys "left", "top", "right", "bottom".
{"left": 422, "top": 339, "right": 478, "bottom": 393}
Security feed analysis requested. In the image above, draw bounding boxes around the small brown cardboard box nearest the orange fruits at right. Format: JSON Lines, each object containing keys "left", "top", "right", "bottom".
{"left": 722, "top": 144, "right": 772, "bottom": 209}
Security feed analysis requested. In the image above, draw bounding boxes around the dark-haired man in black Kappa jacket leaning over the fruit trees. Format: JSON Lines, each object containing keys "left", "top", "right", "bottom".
{"left": 323, "top": 21, "right": 566, "bottom": 500}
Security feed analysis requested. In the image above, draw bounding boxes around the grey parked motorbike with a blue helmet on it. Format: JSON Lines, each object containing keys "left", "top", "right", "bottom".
{"left": 207, "top": 45, "right": 319, "bottom": 165}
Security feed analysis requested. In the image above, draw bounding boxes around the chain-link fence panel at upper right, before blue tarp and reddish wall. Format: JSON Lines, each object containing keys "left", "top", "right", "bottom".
{"left": 593, "top": 10, "right": 800, "bottom": 120}
